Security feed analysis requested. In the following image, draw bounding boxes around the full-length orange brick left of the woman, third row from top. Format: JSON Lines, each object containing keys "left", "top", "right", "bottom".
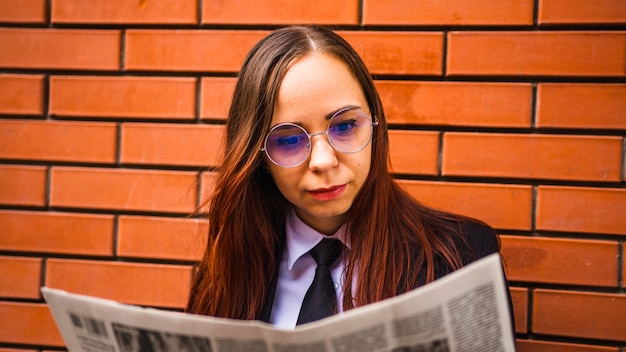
{"left": 50, "top": 76, "right": 196, "bottom": 119}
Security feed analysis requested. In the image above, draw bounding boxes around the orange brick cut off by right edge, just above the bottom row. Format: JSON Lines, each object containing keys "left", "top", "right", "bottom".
{"left": 533, "top": 289, "right": 626, "bottom": 341}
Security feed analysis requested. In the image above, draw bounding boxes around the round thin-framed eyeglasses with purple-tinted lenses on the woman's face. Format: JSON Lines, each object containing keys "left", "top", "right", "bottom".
{"left": 261, "top": 108, "right": 378, "bottom": 167}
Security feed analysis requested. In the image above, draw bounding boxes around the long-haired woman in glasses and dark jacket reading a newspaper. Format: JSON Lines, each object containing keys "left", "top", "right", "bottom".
{"left": 188, "top": 26, "right": 512, "bottom": 327}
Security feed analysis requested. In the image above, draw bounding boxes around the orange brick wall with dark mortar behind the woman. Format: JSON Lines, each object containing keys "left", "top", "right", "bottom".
{"left": 0, "top": 0, "right": 626, "bottom": 352}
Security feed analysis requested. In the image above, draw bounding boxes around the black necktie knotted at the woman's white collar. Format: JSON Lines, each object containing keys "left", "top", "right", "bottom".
{"left": 296, "top": 238, "right": 343, "bottom": 325}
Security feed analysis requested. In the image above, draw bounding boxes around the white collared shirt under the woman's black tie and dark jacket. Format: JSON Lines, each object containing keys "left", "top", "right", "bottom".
{"left": 270, "top": 208, "right": 350, "bottom": 329}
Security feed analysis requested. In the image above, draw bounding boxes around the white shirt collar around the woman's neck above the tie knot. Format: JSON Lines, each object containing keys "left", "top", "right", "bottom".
{"left": 286, "top": 207, "right": 350, "bottom": 270}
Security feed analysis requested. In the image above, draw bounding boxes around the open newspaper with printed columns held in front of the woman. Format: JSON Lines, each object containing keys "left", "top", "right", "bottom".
{"left": 42, "top": 254, "right": 515, "bottom": 352}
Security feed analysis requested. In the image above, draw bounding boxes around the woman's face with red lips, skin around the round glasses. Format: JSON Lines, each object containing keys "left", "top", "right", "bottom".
{"left": 266, "top": 52, "right": 372, "bottom": 235}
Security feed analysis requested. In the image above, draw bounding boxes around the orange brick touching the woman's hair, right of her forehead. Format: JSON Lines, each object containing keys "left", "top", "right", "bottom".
{"left": 376, "top": 81, "right": 532, "bottom": 128}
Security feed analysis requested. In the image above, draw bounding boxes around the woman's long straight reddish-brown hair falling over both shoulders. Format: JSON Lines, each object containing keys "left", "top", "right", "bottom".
{"left": 188, "top": 26, "right": 480, "bottom": 319}
